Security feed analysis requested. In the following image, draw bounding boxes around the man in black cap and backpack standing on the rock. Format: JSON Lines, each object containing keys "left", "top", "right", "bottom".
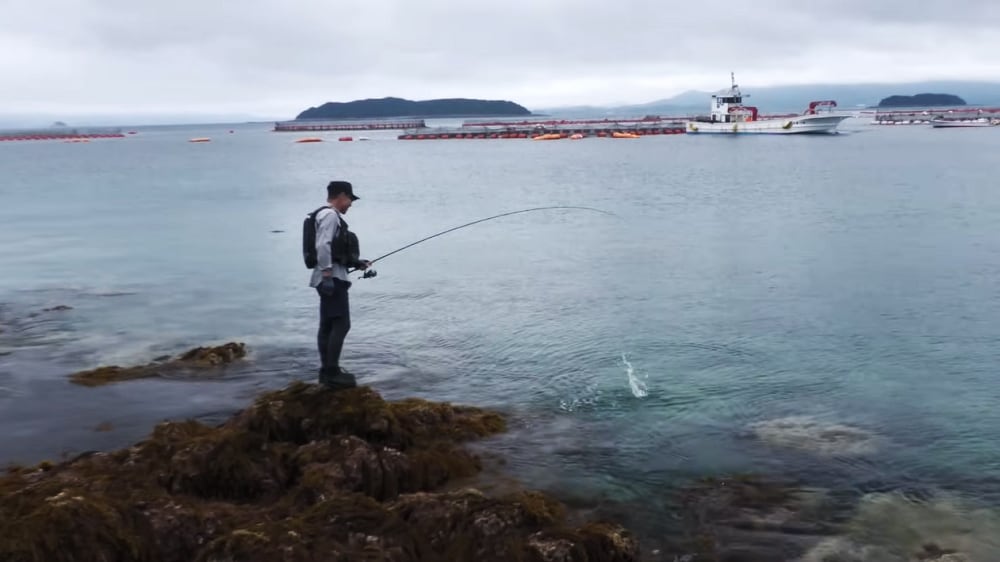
{"left": 304, "top": 180, "right": 371, "bottom": 389}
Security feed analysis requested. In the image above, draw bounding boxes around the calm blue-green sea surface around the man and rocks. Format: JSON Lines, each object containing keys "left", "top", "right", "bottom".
{"left": 0, "top": 119, "right": 1000, "bottom": 552}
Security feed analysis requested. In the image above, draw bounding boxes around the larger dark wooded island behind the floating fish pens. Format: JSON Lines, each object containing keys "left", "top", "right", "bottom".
{"left": 295, "top": 98, "right": 531, "bottom": 120}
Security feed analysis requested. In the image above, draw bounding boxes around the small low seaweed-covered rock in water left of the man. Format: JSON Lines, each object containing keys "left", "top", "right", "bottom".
{"left": 70, "top": 342, "right": 247, "bottom": 386}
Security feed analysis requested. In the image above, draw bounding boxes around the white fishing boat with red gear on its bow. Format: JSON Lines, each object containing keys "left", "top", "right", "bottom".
{"left": 685, "top": 76, "right": 851, "bottom": 135}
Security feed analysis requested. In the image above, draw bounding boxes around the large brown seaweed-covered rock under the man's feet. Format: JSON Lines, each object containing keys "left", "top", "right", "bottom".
{"left": 0, "top": 383, "right": 638, "bottom": 562}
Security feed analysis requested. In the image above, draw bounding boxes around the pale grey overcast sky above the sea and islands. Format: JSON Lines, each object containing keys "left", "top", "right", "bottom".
{"left": 0, "top": 0, "right": 1000, "bottom": 119}
